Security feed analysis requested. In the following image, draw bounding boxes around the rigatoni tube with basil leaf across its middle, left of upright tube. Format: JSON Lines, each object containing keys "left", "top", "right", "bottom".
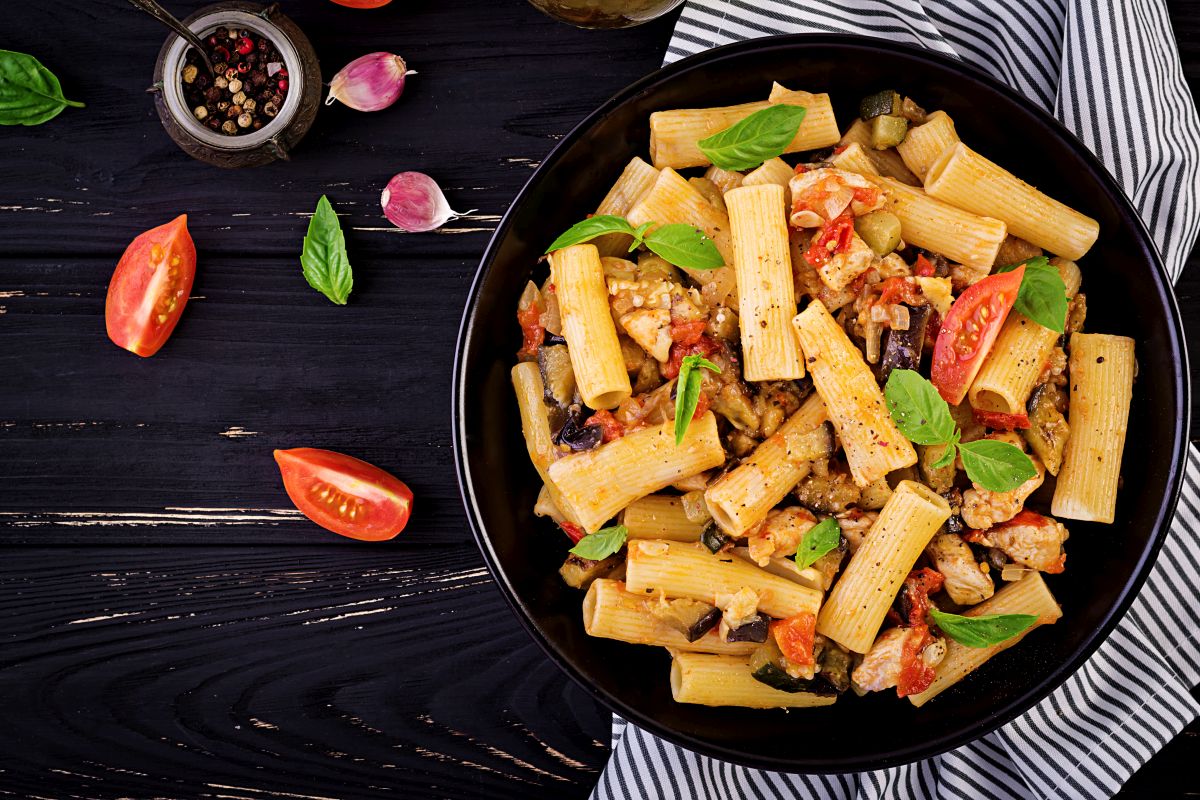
{"left": 625, "top": 169, "right": 737, "bottom": 307}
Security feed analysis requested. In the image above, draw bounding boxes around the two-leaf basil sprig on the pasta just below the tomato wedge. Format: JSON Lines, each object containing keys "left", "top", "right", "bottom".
{"left": 883, "top": 369, "right": 1038, "bottom": 492}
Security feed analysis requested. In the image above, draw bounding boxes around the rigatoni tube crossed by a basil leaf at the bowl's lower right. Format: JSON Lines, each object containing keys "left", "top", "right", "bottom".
{"left": 908, "top": 572, "right": 1062, "bottom": 706}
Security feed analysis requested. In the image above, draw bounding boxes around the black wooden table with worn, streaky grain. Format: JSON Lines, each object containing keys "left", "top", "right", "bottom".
{"left": 0, "top": 0, "right": 1200, "bottom": 799}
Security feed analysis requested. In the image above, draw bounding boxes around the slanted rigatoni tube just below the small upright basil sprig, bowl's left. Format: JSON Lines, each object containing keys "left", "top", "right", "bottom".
{"left": 547, "top": 411, "right": 725, "bottom": 533}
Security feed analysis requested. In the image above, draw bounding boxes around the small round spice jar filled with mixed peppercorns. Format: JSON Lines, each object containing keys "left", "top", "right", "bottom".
{"left": 151, "top": 0, "right": 322, "bottom": 167}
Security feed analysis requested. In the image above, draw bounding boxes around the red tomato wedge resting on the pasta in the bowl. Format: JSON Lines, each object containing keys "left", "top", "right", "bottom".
{"left": 929, "top": 265, "right": 1025, "bottom": 405}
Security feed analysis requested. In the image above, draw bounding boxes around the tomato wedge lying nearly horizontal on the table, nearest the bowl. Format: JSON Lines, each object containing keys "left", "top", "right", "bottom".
{"left": 275, "top": 447, "right": 413, "bottom": 542}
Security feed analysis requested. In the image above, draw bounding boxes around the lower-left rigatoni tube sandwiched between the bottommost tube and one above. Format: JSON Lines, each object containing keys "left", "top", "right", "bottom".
{"left": 583, "top": 578, "right": 758, "bottom": 655}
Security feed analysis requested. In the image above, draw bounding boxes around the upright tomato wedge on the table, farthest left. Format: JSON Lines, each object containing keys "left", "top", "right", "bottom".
{"left": 104, "top": 215, "right": 196, "bottom": 356}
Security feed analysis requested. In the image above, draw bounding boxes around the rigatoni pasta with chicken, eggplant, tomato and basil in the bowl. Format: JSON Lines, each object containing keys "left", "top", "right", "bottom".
{"left": 511, "top": 84, "right": 1136, "bottom": 709}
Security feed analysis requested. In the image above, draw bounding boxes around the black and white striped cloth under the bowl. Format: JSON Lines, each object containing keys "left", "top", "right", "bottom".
{"left": 593, "top": 0, "right": 1200, "bottom": 800}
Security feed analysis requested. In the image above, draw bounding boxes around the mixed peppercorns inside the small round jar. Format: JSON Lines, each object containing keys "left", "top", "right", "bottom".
{"left": 180, "top": 28, "right": 288, "bottom": 136}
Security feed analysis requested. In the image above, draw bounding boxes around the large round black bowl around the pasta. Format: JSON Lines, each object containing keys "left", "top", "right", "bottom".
{"left": 454, "top": 35, "right": 1188, "bottom": 772}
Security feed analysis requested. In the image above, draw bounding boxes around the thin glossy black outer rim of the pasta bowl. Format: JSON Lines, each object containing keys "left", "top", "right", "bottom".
{"left": 451, "top": 34, "right": 1192, "bottom": 774}
